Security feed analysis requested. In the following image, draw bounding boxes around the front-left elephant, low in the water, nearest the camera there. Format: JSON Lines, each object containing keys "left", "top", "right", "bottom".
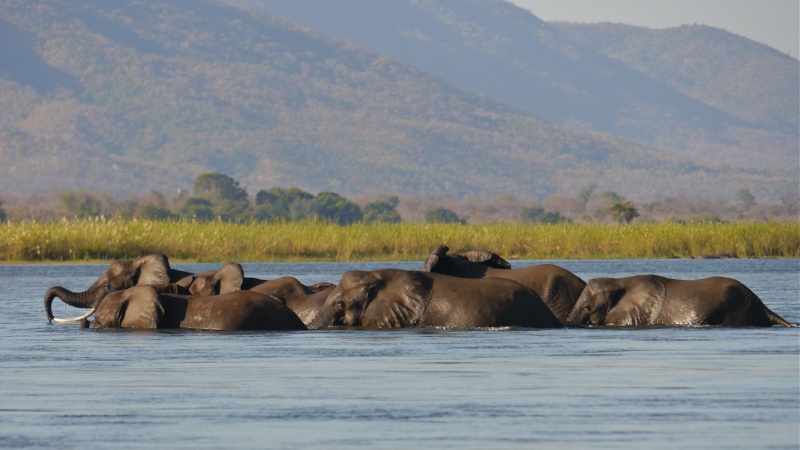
{"left": 93, "top": 284, "right": 306, "bottom": 330}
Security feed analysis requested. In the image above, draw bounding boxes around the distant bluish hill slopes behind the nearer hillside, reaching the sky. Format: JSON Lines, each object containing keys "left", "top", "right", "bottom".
{"left": 241, "top": 0, "right": 800, "bottom": 172}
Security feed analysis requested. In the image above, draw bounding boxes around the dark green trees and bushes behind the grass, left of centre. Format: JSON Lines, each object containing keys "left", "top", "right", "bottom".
{"left": 0, "top": 173, "right": 465, "bottom": 225}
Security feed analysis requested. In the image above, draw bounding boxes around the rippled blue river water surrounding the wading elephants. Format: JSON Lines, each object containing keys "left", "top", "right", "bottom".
{"left": 0, "top": 259, "right": 800, "bottom": 449}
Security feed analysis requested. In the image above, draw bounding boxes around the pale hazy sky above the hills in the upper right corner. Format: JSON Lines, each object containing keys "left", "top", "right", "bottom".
{"left": 509, "top": 0, "right": 800, "bottom": 58}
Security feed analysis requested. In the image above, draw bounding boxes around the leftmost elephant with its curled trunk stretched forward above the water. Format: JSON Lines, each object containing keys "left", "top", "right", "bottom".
{"left": 44, "top": 254, "right": 194, "bottom": 323}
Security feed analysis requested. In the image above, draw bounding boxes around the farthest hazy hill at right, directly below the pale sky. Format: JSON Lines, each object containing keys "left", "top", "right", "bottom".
{"left": 552, "top": 23, "right": 800, "bottom": 170}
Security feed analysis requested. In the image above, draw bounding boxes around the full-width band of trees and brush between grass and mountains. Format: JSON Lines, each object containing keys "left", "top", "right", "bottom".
{"left": 0, "top": 173, "right": 800, "bottom": 225}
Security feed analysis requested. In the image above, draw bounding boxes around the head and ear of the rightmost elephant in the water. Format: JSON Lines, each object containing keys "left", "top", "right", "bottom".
{"left": 566, "top": 277, "right": 666, "bottom": 325}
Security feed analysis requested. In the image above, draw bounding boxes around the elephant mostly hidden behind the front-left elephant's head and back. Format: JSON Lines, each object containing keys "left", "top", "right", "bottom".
{"left": 184, "top": 262, "right": 334, "bottom": 325}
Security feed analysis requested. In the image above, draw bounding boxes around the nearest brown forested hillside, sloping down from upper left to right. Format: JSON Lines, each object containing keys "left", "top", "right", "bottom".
{"left": 0, "top": 0, "right": 796, "bottom": 199}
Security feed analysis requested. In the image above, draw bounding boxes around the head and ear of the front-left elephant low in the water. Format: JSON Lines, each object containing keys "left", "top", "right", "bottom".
{"left": 95, "top": 285, "right": 164, "bottom": 329}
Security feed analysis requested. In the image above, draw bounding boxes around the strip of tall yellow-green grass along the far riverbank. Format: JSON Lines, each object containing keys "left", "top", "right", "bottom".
{"left": 0, "top": 217, "right": 800, "bottom": 262}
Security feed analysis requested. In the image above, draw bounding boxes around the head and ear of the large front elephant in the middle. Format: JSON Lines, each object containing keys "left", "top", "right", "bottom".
{"left": 309, "top": 270, "right": 431, "bottom": 328}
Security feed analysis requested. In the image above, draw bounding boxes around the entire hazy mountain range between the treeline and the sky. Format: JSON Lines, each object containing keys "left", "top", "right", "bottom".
{"left": 0, "top": 0, "right": 800, "bottom": 199}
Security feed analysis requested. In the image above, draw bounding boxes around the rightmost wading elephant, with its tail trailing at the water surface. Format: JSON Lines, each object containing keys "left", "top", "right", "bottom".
{"left": 567, "top": 275, "right": 793, "bottom": 327}
